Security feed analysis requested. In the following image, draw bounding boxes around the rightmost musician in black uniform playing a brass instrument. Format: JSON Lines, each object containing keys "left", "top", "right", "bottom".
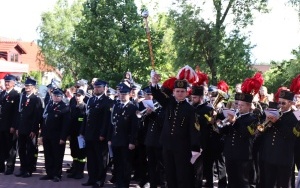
{"left": 262, "top": 90, "right": 300, "bottom": 188}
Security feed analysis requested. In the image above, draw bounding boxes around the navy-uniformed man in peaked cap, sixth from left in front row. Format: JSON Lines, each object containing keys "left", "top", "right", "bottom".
{"left": 109, "top": 84, "right": 138, "bottom": 188}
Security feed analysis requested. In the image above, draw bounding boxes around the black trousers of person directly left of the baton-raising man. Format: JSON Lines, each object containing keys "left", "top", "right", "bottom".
{"left": 146, "top": 146, "right": 164, "bottom": 188}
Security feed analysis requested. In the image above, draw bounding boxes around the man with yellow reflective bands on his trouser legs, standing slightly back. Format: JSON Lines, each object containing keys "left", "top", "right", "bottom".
{"left": 67, "top": 89, "right": 86, "bottom": 179}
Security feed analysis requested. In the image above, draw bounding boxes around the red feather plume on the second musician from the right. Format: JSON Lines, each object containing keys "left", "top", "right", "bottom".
{"left": 241, "top": 72, "right": 264, "bottom": 95}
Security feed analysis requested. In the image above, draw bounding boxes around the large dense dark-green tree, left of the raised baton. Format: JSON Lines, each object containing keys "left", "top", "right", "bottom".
{"left": 70, "top": 0, "right": 169, "bottom": 85}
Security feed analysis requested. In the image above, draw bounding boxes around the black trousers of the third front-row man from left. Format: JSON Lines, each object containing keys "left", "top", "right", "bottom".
{"left": 43, "top": 138, "right": 66, "bottom": 177}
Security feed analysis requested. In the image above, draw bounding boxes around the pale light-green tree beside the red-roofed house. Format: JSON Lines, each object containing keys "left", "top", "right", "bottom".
{"left": 38, "top": 0, "right": 83, "bottom": 84}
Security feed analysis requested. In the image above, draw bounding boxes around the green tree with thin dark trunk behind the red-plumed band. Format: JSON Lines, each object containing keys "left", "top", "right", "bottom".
{"left": 169, "top": 0, "right": 267, "bottom": 84}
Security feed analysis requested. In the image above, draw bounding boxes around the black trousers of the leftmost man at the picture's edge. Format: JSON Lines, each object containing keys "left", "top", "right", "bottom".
{"left": 0, "top": 130, "right": 17, "bottom": 171}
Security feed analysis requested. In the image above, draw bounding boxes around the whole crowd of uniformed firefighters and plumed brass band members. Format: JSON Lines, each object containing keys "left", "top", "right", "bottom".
{"left": 0, "top": 67, "right": 300, "bottom": 188}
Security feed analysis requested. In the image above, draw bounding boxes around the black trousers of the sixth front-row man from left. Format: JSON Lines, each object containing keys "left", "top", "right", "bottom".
{"left": 112, "top": 146, "right": 133, "bottom": 188}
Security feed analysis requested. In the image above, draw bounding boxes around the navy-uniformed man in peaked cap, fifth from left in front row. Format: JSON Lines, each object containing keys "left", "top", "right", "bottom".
{"left": 81, "top": 80, "right": 110, "bottom": 187}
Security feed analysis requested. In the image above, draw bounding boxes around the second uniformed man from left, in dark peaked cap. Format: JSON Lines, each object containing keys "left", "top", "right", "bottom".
{"left": 16, "top": 77, "right": 43, "bottom": 178}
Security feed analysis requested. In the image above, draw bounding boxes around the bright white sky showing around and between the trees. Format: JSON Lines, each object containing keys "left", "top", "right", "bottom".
{"left": 0, "top": 0, "right": 300, "bottom": 63}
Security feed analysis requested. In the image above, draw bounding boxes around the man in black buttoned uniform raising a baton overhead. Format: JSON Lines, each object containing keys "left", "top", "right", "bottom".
{"left": 151, "top": 74, "right": 200, "bottom": 188}
